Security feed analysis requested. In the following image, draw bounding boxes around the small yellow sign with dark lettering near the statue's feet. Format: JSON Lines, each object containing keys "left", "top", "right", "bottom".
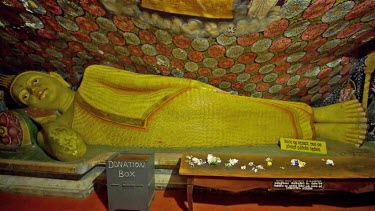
{"left": 280, "top": 138, "right": 327, "bottom": 154}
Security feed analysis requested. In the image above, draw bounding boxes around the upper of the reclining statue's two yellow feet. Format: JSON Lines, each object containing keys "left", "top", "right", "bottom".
{"left": 313, "top": 100, "right": 368, "bottom": 124}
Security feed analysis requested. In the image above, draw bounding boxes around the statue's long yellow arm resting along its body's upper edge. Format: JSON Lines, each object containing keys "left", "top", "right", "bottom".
{"left": 83, "top": 65, "right": 222, "bottom": 91}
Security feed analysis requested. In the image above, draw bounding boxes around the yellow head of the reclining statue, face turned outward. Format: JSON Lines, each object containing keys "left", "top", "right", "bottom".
{"left": 10, "top": 71, "right": 70, "bottom": 110}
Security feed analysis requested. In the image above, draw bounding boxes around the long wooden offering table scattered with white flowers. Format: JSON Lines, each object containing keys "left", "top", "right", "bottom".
{"left": 179, "top": 153, "right": 375, "bottom": 211}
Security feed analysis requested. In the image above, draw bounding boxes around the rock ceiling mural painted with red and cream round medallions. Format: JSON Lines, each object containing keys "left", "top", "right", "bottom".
{"left": 0, "top": 0, "right": 375, "bottom": 104}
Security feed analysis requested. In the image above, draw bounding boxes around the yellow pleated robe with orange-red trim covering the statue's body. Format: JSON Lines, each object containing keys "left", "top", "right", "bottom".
{"left": 72, "top": 65, "right": 315, "bottom": 148}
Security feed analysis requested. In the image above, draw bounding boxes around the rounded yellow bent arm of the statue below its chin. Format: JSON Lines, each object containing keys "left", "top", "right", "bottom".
{"left": 42, "top": 123, "right": 86, "bottom": 161}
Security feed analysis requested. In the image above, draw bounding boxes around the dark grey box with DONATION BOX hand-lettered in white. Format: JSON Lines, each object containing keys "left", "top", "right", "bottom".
{"left": 106, "top": 153, "right": 155, "bottom": 211}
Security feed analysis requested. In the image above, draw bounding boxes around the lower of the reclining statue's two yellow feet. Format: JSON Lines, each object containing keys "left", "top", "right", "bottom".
{"left": 315, "top": 123, "right": 368, "bottom": 147}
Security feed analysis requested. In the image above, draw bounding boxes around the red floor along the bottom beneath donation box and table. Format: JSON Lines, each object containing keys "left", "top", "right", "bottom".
{"left": 0, "top": 188, "right": 375, "bottom": 211}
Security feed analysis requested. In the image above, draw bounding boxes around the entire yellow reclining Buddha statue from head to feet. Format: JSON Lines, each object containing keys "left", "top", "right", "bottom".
{"left": 10, "top": 65, "right": 367, "bottom": 161}
